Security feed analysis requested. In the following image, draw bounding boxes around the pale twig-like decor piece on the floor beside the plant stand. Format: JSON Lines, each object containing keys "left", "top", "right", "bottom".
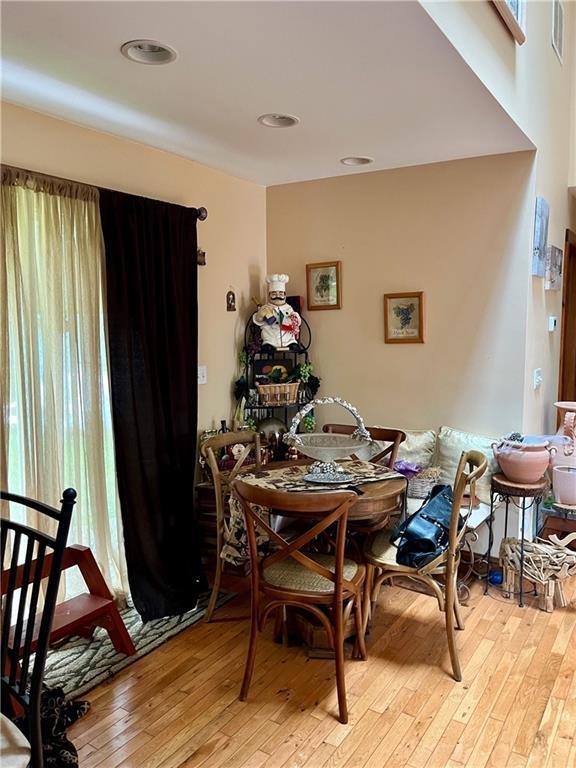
{"left": 500, "top": 534, "right": 576, "bottom": 613}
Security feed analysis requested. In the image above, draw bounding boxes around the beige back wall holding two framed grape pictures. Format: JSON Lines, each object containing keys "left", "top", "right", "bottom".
{"left": 267, "top": 152, "right": 533, "bottom": 435}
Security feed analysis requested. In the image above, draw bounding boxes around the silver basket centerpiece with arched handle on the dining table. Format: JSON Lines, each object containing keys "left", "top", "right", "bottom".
{"left": 283, "top": 397, "right": 373, "bottom": 483}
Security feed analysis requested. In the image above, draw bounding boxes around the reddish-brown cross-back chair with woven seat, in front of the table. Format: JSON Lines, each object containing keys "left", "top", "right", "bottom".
{"left": 232, "top": 479, "right": 366, "bottom": 723}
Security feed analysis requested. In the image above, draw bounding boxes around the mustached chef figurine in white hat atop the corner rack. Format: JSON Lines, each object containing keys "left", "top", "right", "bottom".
{"left": 252, "top": 275, "right": 302, "bottom": 353}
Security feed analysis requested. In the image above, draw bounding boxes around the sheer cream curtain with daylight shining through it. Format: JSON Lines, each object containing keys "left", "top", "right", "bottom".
{"left": 0, "top": 167, "right": 128, "bottom": 594}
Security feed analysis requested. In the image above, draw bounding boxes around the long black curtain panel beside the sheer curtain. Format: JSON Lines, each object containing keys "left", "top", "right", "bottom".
{"left": 100, "top": 189, "right": 206, "bottom": 621}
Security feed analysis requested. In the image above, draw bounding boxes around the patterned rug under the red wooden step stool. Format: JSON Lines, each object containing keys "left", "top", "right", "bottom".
{"left": 44, "top": 592, "right": 235, "bottom": 699}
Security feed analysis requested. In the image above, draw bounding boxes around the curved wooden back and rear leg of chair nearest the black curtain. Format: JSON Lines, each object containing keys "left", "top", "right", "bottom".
{"left": 200, "top": 430, "right": 262, "bottom": 621}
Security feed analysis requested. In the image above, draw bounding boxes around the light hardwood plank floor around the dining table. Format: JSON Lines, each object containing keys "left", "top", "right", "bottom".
{"left": 69, "top": 580, "right": 576, "bottom": 768}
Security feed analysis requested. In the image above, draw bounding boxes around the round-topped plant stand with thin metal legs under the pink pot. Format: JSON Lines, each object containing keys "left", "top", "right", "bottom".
{"left": 484, "top": 474, "right": 546, "bottom": 608}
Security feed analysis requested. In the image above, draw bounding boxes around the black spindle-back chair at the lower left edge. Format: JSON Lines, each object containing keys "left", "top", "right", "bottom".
{"left": 0, "top": 488, "right": 76, "bottom": 768}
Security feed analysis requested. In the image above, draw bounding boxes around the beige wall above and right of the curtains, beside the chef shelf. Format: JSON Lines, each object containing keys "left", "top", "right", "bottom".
{"left": 2, "top": 104, "right": 266, "bottom": 429}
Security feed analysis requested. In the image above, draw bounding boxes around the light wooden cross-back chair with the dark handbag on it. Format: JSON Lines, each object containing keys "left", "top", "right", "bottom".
{"left": 363, "top": 451, "right": 487, "bottom": 681}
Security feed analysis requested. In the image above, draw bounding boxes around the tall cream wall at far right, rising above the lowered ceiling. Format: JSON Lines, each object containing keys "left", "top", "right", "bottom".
{"left": 422, "top": 0, "right": 576, "bottom": 433}
